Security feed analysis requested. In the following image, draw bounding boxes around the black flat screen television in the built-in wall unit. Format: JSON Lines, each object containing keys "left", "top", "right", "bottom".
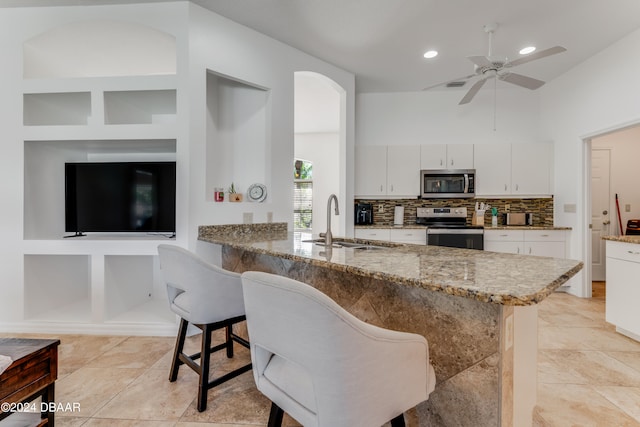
{"left": 65, "top": 162, "right": 176, "bottom": 236}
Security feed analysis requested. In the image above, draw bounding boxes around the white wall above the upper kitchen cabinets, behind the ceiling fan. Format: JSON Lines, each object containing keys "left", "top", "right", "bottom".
{"left": 356, "top": 86, "right": 540, "bottom": 145}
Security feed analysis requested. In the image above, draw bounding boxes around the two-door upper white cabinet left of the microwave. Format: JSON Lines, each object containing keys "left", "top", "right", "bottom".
{"left": 355, "top": 145, "right": 420, "bottom": 197}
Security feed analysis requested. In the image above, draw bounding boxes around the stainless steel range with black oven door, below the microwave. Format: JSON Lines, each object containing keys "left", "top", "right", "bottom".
{"left": 416, "top": 207, "right": 484, "bottom": 250}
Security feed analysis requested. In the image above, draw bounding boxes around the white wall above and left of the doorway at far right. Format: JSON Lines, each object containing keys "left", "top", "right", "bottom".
{"left": 540, "top": 30, "right": 640, "bottom": 296}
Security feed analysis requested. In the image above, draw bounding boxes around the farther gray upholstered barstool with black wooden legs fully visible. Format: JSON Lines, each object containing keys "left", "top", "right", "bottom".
{"left": 158, "top": 245, "right": 251, "bottom": 412}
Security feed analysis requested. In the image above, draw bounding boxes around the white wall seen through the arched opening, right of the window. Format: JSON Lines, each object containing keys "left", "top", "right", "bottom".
{"left": 295, "top": 132, "right": 342, "bottom": 236}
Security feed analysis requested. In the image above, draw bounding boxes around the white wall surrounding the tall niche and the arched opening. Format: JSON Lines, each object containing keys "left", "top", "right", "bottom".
{"left": 189, "top": 5, "right": 355, "bottom": 249}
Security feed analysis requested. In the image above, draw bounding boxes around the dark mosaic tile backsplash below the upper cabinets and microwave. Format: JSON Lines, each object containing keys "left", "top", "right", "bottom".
{"left": 355, "top": 198, "right": 553, "bottom": 227}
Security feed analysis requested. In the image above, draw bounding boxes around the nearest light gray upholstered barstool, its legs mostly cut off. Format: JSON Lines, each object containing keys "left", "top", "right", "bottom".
{"left": 242, "top": 272, "right": 435, "bottom": 427}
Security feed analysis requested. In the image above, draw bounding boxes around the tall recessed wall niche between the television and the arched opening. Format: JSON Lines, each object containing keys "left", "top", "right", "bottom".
{"left": 205, "top": 71, "right": 271, "bottom": 201}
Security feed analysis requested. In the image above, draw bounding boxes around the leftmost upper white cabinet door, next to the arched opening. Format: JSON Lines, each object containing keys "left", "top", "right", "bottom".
{"left": 355, "top": 146, "right": 387, "bottom": 197}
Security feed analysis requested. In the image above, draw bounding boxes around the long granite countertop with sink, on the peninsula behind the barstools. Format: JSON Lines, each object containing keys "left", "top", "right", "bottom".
{"left": 198, "top": 223, "right": 582, "bottom": 305}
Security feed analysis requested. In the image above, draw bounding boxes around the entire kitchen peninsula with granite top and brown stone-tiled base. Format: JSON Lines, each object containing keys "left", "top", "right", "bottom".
{"left": 199, "top": 223, "right": 582, "bottom": 426}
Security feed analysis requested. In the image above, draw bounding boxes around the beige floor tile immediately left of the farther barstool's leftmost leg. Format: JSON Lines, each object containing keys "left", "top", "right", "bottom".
{"left": 87, "top": 337, "right": 173, "bottom": 368}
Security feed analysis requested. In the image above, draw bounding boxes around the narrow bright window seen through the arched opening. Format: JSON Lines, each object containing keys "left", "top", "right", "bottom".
{"left": 293, "top": 159, "right": 313, "bottom": 232}
